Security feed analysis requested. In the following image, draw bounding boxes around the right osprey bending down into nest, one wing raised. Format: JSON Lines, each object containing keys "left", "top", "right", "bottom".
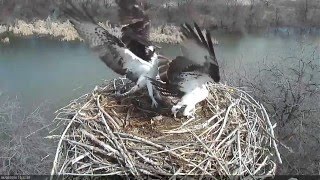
{"left": 151, "top": 23, "right": 220, "bottom": 117}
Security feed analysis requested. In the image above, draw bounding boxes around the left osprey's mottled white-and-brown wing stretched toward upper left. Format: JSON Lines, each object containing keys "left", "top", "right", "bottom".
{"left": 60, "top": 1, "right": 149, "bottom": 81}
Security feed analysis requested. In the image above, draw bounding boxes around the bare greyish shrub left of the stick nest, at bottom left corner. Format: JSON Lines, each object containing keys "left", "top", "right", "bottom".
{"left": 0, "top": 95, "right": 54, "bottom": 175}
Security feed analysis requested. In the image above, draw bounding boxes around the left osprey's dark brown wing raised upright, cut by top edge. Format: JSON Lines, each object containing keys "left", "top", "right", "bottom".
{"left": 116, "top": 0, "right": 152, "bottom": 61}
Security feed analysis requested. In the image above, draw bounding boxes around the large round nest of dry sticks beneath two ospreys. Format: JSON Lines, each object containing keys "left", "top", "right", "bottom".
{"left": 49, "top": 80, "right": 281, "bottom": 179}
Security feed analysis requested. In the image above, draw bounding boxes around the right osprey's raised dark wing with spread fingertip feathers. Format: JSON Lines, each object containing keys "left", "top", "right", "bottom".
{"left": 159, "top": 23, "right": 220, "bottom": 83}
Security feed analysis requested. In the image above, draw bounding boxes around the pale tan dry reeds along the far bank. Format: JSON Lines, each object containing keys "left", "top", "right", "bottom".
{"left": 0, "top": 18, "right": 218, "bottom": 44}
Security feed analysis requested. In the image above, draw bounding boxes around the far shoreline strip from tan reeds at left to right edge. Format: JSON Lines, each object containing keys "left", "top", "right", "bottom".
{"left": 0, "top": 17, "right": 320, "bottom": 44}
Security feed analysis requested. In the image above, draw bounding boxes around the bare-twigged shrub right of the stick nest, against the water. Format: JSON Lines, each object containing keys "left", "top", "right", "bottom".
{"left": 234, "top": 43, "right": 320, "bottom": 174}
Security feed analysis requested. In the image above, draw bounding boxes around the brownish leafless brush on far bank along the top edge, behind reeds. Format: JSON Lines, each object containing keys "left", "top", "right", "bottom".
{"left": 0, "top": 0, "right": 320, "bottom": 32}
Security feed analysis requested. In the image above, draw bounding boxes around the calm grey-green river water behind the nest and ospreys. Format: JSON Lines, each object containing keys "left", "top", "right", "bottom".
{"left": 0, "top": 33, "right": 320, "bottom": 117}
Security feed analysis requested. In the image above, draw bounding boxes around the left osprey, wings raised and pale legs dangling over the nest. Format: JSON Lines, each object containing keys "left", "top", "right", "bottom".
{"left": 61, "top": 0, "right": 164, "bottom": 107}
